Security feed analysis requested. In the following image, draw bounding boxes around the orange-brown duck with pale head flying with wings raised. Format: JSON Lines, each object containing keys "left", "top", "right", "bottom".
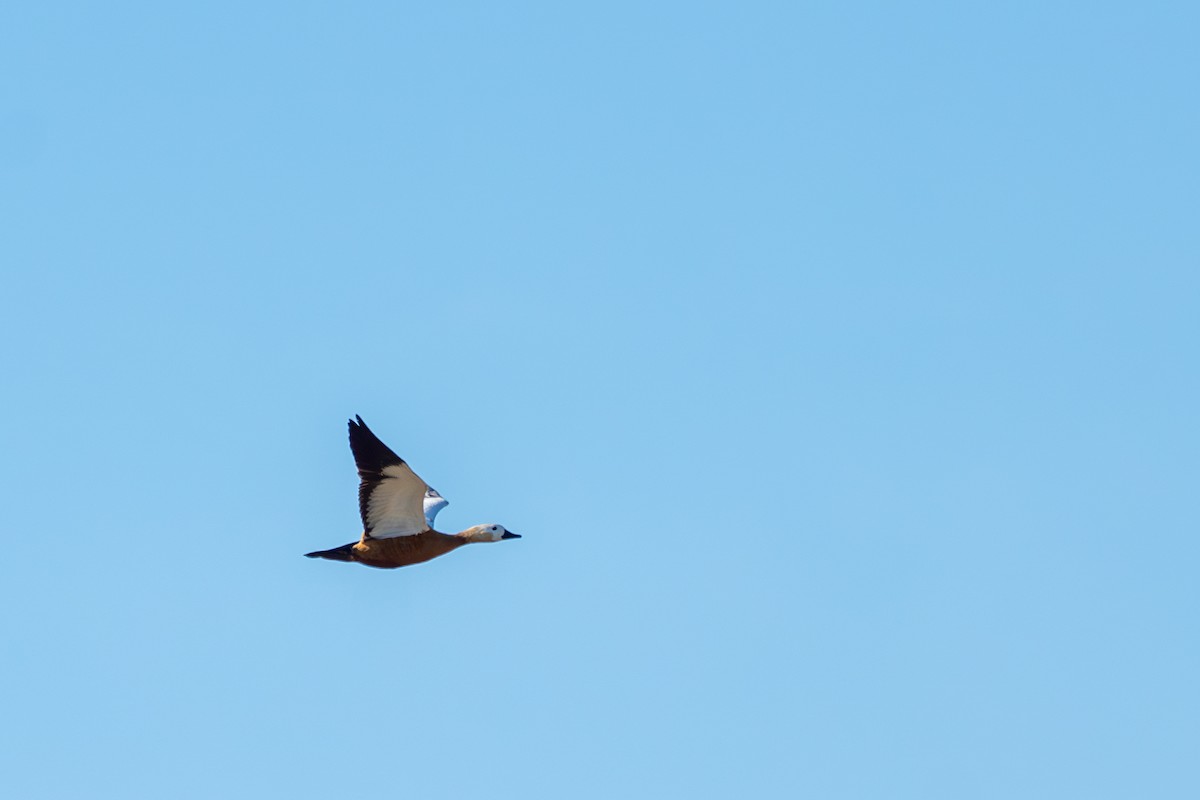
{"left": 305, "top": 415, "right": 521, "bottom": 570}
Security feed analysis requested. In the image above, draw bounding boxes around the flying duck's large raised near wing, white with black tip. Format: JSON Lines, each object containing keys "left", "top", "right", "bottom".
{"left": 350, "top": 416, "right": 440, "bottom": 539}
